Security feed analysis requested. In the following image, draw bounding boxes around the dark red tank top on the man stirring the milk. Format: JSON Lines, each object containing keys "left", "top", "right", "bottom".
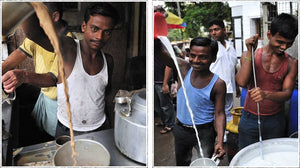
{"left": 244, "top": 48, "right": 289, "bottom": 116}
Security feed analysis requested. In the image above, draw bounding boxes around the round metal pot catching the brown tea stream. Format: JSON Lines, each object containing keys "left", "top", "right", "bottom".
{"left": 53, "top": 139, "right": 110, "bottom": 166}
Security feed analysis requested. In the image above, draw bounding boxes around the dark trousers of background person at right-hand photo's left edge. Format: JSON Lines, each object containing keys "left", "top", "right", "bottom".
{"left": 154, "top": 83, "right": 175, "bottom": 128}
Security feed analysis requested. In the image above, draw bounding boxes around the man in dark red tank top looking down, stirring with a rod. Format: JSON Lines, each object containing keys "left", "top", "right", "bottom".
{"left": 235, "top": 13, "right": 298, "bottom": 150}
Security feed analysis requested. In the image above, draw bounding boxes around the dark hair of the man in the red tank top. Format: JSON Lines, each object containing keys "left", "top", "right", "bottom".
{"left": 270, "top": 13, "right": 298, "bottom": 39}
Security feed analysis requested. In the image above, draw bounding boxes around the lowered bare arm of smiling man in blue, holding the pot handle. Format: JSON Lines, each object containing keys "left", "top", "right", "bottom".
{"left": 211, "top": 78, "right": 226, "bottom": 157}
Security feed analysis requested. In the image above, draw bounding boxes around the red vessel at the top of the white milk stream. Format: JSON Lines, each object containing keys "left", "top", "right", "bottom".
{"left": 154, "top": 12, "right": 168, "bottom": 38}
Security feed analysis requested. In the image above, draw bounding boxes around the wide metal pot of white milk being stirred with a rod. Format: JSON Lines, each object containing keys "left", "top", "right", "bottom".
{"left": 229, "top": 138, "right": 299, "bottom": 167}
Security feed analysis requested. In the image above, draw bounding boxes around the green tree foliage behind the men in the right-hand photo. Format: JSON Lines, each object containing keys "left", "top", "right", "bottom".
{"left": 165, "top": 2, "right": 230, "bottom": 38}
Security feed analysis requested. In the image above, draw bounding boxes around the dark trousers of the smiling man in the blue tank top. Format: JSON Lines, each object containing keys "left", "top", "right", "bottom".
{"left": 173, "top": 123, "right": 217, "bottom": 166}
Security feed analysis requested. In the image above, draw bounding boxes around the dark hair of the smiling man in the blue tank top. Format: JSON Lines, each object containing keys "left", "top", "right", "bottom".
{"left": 190, "top": 37, "right": 219, "bottom": 59}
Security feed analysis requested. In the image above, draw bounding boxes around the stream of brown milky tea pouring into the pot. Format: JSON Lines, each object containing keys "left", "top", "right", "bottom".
{"left": 30, "top": 2, "right": 77, "bottom": 166}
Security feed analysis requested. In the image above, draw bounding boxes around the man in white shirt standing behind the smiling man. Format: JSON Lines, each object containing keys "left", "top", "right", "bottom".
{"left": 208, "top": 19, "right": 240, "bottom": 142}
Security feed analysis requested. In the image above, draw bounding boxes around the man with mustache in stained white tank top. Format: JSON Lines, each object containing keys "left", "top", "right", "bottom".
{"left": 56, "top": 3, "right": 119, "bottom": 137}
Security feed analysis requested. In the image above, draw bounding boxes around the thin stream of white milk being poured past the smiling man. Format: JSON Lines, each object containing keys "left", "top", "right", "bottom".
{"left": 158, "top": 36, "right": 204, "bottom": 157}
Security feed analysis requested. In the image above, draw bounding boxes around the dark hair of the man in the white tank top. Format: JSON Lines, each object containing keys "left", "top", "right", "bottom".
{"left": 84, "top": 2, "right": 120, "bottom": 26}
